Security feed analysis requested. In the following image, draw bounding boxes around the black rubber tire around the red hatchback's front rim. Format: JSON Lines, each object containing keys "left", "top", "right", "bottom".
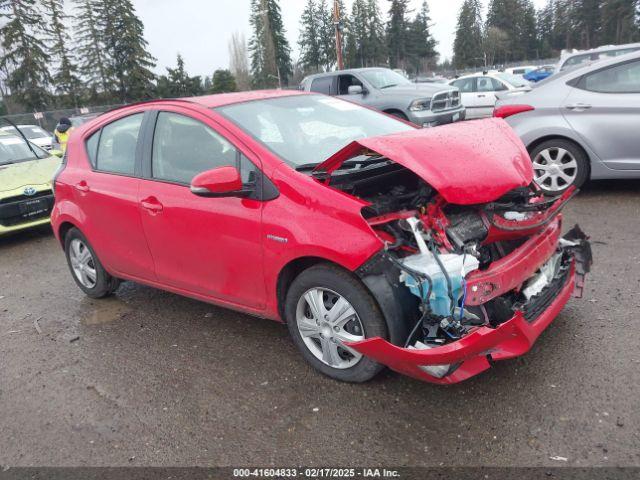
{"left": 284, "top": 264, "right": 388, "bottom": 383}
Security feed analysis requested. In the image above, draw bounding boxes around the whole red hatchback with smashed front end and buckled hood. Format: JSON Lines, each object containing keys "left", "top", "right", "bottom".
{"left": 52, "top": 92, "right": 591, "bottom": 383}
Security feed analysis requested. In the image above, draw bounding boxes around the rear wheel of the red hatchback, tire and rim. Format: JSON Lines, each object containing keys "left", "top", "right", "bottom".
{"left": 64, "top": 228, "right": 120, "bottom": 298}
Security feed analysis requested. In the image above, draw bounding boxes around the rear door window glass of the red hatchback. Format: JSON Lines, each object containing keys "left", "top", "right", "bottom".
{"left": 95, "top": 113, "right": 144, "bottom": 175}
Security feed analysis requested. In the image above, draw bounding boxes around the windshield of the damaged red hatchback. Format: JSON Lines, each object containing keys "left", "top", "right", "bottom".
{"left": 217, "top": 95, "right": 414, "bottom": 168}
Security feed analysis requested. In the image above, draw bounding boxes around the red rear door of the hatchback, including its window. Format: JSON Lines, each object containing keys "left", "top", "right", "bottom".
{"left": 73, "top": 112, "right": 155, "bottom": 280}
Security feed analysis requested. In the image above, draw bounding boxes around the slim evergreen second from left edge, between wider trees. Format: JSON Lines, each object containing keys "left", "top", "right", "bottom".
{"left": 42, "top": 0, "right": 80, "bottom": 107}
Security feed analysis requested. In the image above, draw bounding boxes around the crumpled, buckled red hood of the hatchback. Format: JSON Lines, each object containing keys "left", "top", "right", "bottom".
{"left": 314, "top": 118, "right": 533, "bottom": 205}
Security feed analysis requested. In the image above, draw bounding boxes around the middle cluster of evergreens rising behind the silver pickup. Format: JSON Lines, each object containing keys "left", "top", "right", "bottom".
{"left": 249, "top": 0, "right": 438, "bottom": 87}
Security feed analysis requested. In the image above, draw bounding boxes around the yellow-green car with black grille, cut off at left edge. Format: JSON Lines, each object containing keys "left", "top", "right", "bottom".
{"left": 0, "top": 132, "right": 61, "bottom": 236}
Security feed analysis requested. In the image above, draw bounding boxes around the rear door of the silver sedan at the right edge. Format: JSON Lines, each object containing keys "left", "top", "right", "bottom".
{"left": 562, "top": 59, "right": 640, "bottom": 170}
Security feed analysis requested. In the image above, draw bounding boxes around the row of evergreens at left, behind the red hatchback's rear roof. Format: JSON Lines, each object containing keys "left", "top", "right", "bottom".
{"left": 0, "top": 0, "right": 236, "bottom": 112}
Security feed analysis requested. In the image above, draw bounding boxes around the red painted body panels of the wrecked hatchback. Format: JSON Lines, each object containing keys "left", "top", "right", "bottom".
{"left": 52, "top": 91, "right": 588, "bottom": 383}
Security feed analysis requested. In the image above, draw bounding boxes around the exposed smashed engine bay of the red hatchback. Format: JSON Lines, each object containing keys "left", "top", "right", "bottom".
{"left": 325, "top": 160, "right": 591, "bottom": 378}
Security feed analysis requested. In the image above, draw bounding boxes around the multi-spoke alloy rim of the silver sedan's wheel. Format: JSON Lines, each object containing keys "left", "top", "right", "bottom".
{"left": 533, "top": 147, "right": 578, "bottom": 192}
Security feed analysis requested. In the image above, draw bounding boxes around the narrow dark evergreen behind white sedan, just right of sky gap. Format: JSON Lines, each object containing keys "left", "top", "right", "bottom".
{"left": 453, "top": 0, "right": 484, "bottom": 68}
